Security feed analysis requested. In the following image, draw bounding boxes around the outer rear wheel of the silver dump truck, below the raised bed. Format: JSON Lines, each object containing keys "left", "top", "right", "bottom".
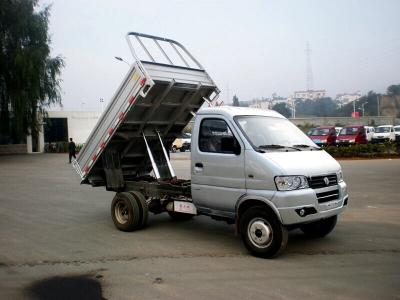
{"left": 111, "top": 193, "right": 141, "bottom": 231}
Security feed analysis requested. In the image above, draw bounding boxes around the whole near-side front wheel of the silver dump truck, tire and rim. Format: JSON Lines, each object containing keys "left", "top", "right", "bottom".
{"left": 239, "top": 206, "right": 288, "bottom": 258}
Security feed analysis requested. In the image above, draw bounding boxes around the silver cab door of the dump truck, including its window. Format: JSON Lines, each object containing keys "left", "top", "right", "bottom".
{"left": 191, "top": 115, "right": 246, "bottom": 217}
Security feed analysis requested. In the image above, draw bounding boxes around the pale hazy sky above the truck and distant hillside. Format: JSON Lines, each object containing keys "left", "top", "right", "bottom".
{"left": 45, "top": 0, "right": 400, "bottom": 110}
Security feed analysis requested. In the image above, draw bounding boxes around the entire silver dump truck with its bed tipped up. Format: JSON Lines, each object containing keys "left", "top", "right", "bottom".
{"left": 73, "top": 32, "right": 348, "bottom": 258}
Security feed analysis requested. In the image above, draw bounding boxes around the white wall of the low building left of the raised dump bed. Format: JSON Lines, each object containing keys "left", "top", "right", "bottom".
{"left": 48, "top": 111, "right": 101, "bottom": 144}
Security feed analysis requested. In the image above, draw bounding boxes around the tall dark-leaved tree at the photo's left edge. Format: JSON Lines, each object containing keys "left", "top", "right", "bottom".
{"left": 0, "top": 0, "right": 64, "bottom": 143}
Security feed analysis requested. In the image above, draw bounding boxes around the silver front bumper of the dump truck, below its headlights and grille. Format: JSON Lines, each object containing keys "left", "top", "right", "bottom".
{"left": 271, "top": 182, "right": 349, "bottom": 225}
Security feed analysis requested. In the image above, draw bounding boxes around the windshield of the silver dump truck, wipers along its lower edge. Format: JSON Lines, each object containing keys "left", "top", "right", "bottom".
{"left": 235, "top": 116, "right": 317, "bottom": 151}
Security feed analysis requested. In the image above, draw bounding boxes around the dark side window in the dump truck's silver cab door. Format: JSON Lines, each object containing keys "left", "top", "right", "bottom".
{"left": 199, "top": 119, "right": 240, "bottom": 154}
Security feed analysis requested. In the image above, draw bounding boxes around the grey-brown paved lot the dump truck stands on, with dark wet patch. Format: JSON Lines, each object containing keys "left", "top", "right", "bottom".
{"left": 0, "top": 153, "right": 400, "bottom": 299}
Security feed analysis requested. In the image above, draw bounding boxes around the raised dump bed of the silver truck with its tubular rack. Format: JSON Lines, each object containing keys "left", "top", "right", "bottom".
{"left": 73, "top": 32, "right": 219, "bottom": 190}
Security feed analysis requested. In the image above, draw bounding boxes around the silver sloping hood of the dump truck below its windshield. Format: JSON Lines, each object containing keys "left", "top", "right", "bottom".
{"left": 263, "top": 150, "right": 341, "bottom": 176}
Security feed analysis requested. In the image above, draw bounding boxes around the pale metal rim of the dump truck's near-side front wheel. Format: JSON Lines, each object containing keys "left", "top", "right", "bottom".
{"left": 247, "top": 218, "right": 273, "bottom": 248}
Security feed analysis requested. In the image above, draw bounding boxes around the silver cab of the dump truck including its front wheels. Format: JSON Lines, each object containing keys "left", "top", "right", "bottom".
{"left": 191, "top": 107, "right": 348, "bottom": 256}
